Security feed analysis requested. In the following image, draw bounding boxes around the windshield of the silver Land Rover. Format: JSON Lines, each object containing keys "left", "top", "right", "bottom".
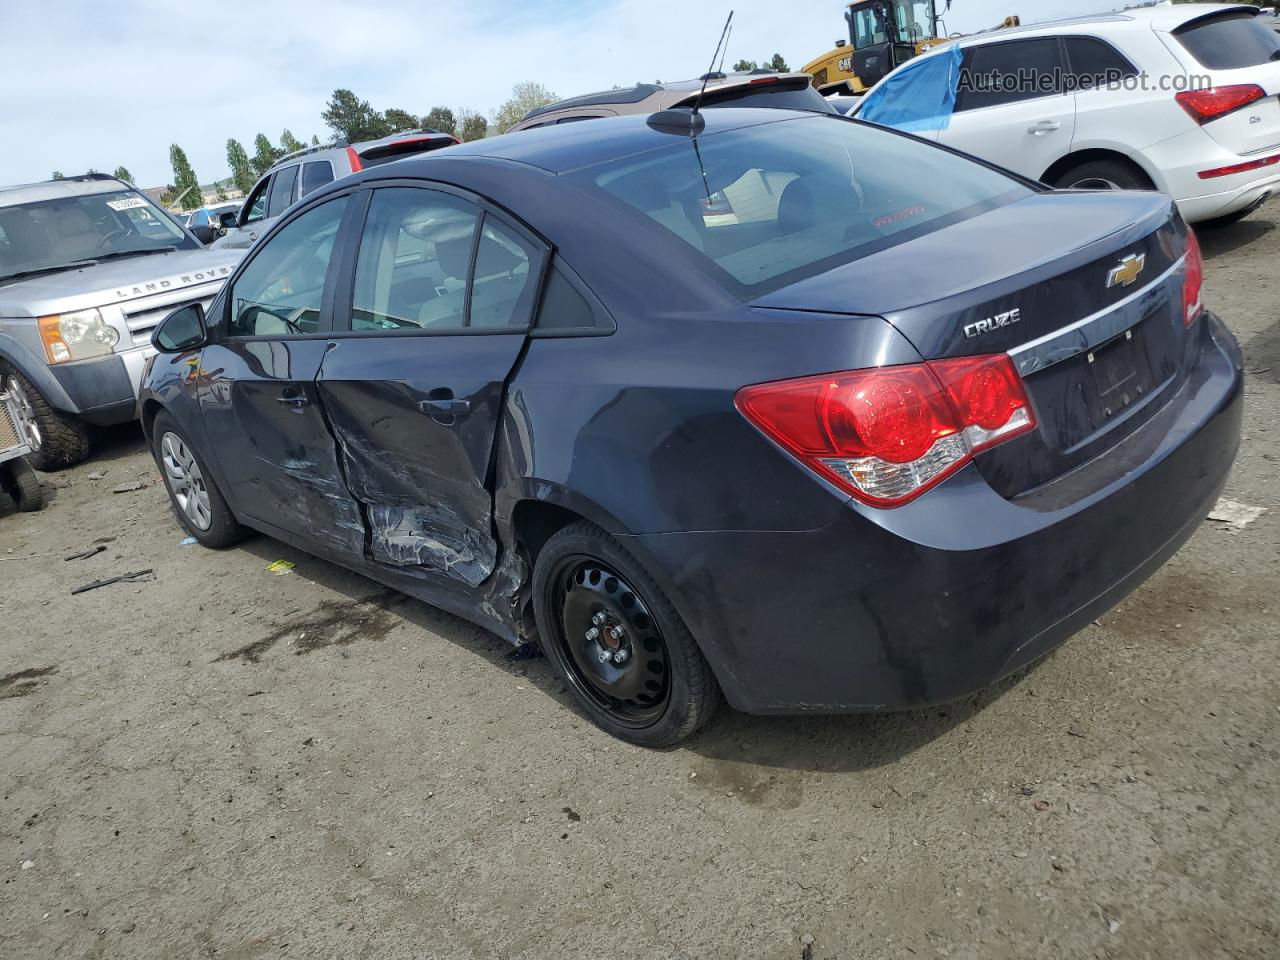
{"left": 0, "top": 189, "right": 196, "bottom": 282}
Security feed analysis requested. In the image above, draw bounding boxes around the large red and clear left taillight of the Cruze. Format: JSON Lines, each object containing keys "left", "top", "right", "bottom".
{"left": 735, "top": 353, "right": 1036, "bottom": 507}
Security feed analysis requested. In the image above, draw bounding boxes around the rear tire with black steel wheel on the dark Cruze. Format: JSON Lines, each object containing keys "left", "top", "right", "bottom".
{"left": 534, "top": 521, "right": 721, "bottom": 748}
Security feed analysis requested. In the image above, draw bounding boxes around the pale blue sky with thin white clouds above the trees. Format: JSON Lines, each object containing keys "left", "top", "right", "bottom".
{"left": 0, "top": 0, "right": 1117, "bottom": 187}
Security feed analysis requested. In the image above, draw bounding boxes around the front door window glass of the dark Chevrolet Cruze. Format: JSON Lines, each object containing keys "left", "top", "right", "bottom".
{"left": 228, "top": 197, "right": 347, "bottom": 338}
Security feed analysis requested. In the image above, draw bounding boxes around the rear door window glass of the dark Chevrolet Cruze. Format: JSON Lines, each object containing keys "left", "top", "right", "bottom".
{"left": 351, "top": 187, "right": 536, "bottom": 333}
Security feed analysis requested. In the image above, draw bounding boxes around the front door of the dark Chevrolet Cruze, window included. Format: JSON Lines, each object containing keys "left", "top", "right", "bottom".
{"left": 198, "top": 195, "right": 365, "bottom": 558}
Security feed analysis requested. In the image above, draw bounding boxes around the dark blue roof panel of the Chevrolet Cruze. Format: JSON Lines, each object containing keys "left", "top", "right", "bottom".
{"left": 381, "top": 108, "right": 808, "bottom": 178}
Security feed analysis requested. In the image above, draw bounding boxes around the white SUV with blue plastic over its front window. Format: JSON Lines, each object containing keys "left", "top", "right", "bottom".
{"left": 856, "top": 4, "right": 1280, "bottom": 224}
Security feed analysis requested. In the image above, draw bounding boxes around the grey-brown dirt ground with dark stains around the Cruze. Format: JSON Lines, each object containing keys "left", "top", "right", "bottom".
{"left": 0, "top": 212, "right": 1280, "bottom": 960}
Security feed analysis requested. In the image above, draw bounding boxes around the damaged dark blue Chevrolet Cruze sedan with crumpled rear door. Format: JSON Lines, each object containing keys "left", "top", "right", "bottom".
{"left": 142, "top": 109, "right": 1242, "bottom": 746}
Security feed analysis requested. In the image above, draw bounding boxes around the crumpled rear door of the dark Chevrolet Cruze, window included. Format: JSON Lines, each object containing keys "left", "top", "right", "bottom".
{"left": 317, "top": 183, "right": 547, "bottom": 590}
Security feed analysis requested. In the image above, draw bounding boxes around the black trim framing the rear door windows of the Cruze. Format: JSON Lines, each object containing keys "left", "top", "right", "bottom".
{"left": 328, "top": 178, "right": 553, "bottom": 339}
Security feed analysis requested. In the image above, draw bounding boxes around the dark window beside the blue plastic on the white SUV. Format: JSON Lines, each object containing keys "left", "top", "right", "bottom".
{"left": 956, "top": 37, "right": 1062, "bottom": 113}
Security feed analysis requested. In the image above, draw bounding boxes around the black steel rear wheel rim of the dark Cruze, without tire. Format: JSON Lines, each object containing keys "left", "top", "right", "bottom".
{"left": 550, "top": 557, "right": 671, "bottom": 727}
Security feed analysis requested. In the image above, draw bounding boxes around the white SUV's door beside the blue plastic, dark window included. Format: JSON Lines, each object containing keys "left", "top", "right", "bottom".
{"left": 938, "top": 37, "right": 1075, "bottom": 179}
